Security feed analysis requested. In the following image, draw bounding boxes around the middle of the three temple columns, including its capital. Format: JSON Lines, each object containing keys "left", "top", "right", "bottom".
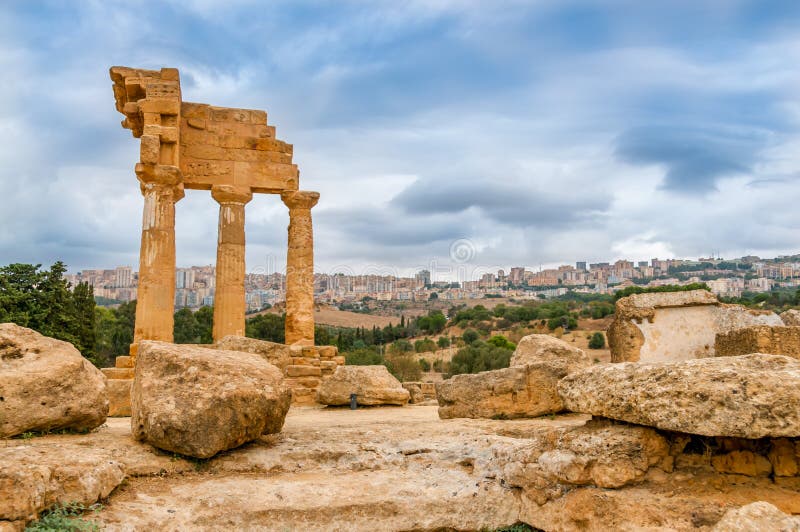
{"left": 211, "top": 185, "right": 253, "bottom": 342}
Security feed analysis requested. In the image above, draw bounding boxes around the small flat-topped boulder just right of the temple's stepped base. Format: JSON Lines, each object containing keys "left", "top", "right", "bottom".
{"left": 317, "top": 366, "right": 411, "bottom": 406}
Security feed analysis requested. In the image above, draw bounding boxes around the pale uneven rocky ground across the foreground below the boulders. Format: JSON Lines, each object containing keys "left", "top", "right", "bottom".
{"left": 6, "top": 406, "right": 800, "bottom": 530}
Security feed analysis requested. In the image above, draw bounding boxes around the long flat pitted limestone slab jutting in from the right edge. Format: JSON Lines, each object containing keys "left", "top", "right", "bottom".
{"left": 558, "top": 353, "right": 800, "bottom": 438}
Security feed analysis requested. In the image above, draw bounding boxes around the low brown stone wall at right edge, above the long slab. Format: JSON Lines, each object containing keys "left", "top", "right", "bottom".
{"left": 714, "top": 325, "right": 800, "bottom": 359}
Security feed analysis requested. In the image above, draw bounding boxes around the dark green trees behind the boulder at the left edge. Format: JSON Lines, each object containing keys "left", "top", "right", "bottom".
{"left": 0, "top": 261, "right": 99, "bottom": 363}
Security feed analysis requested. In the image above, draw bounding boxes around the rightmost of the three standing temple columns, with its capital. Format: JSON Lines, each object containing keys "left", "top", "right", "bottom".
{"left": 281, "top": 191, "right": 319, "bottom": 345}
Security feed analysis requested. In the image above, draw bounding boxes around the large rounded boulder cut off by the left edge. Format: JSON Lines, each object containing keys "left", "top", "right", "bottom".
{"left": 0, "top": 323, "right": 108, "bottom": 438}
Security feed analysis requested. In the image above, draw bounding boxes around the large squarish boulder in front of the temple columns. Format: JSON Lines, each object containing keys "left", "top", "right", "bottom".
{"left": 131, "top": 341, "right": 291, "bottom": 458}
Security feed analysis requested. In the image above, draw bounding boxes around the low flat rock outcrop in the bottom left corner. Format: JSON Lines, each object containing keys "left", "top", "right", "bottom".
{"left": 0, "top": 443, "right": 125, "bottom": 523}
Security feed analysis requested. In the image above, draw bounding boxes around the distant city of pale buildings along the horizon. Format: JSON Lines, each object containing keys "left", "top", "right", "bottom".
{"left": 67, "top": 255, "right": 800, "bottom": 311}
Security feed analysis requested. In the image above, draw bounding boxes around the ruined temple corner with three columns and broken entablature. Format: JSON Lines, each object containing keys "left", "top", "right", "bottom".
{"left": 111, "top": 67, "right": 319, "bottom": 352}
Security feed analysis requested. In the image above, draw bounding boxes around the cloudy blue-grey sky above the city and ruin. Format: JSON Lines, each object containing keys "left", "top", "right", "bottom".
{"left": 0, "top": 0, "right": 800, "bottom": 278}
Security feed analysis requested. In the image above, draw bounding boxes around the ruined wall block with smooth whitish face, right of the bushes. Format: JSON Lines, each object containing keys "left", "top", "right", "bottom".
{"left": 607, "top": 290, "right": 782, "bottom": 362}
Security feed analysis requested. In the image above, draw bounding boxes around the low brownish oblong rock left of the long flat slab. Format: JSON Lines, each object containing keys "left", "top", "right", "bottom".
{"left": 436, "top": 361, "right": 571, "bottom": 419}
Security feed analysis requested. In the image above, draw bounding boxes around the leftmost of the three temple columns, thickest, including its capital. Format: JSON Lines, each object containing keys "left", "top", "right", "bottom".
{"left": 131, "top": 163, "right": 183, "bottom": 357}
